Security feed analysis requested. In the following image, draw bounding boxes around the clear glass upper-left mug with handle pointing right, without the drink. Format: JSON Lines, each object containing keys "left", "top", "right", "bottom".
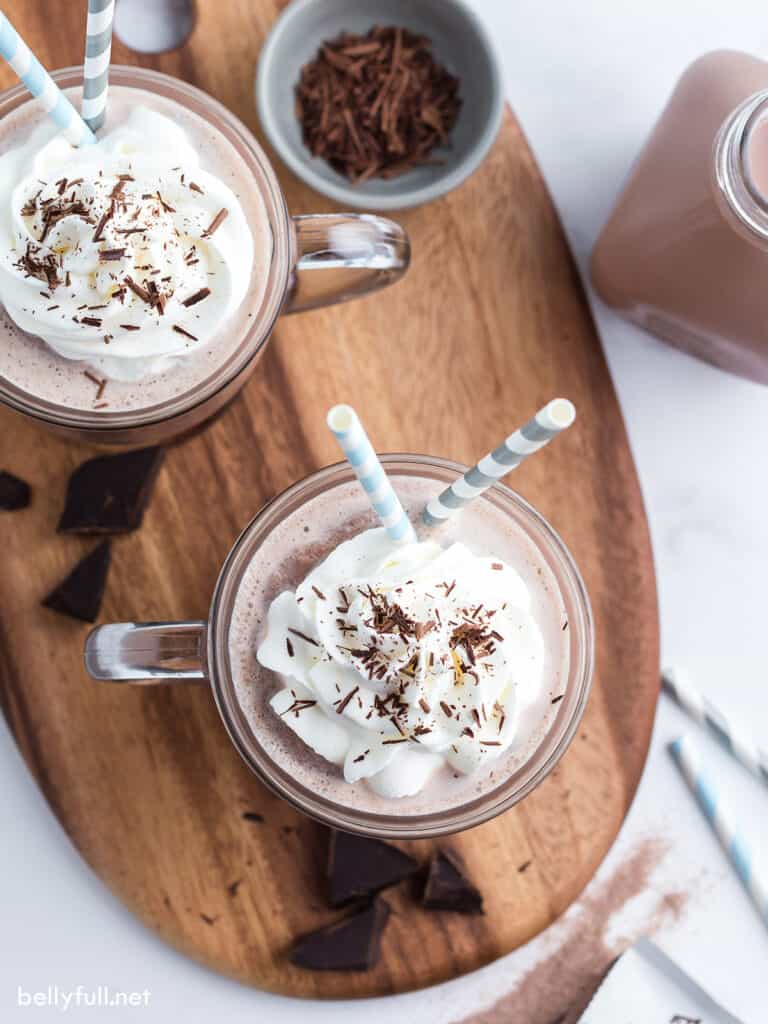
{"left": 0, "top": 66, "right": 411, "bottom": 445}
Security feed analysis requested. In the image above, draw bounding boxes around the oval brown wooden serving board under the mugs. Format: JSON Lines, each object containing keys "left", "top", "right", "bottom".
{"left": 0, "top": 0, "right": 658, "bottom": 996}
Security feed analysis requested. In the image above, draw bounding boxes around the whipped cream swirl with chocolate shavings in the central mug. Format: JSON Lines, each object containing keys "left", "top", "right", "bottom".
{"left": 257, "top": 529, "right": 544, "bottom": 798}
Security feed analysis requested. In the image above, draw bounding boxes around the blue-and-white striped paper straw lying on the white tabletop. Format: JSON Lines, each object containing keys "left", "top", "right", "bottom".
{"left": 670, "top": 736, "right": 768, "bottom": 926}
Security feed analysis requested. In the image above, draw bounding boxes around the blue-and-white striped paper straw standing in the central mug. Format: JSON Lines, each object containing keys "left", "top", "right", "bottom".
{"left": 327, "top": 406, "right": 416, "bottom": 542}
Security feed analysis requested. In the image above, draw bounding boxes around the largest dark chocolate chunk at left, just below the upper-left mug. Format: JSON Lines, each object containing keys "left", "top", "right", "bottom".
{"left": 58, "top": 447, "right": 163, "bottom": 534}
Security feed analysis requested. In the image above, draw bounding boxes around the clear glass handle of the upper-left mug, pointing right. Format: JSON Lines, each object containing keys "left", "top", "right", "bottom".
{"left": 284, "top": 213, "right": 411, "bottom": 313}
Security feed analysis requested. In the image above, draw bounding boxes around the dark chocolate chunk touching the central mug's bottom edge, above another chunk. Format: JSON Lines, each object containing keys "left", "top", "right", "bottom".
{"left": 328, "top": 831, "right": 419, "bottom": 906}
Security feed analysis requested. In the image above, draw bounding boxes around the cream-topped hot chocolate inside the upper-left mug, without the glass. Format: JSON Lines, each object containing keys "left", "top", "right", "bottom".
{"left": 0, "top": 78, "right": 272, "bottom": 413}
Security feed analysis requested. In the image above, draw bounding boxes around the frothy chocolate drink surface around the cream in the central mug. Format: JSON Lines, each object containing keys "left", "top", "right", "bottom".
{"left": 228, "top": 475, "right": 569, "bottom": 815}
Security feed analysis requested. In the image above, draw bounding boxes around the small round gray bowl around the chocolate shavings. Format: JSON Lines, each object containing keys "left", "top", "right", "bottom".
{"left": 256, "top": 0, "right": 504, "bottom": 210}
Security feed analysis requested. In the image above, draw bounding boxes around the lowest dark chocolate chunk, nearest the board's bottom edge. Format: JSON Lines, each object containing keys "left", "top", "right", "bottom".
{"left": 291, "top": 899, "right": 390, "bottom": 971}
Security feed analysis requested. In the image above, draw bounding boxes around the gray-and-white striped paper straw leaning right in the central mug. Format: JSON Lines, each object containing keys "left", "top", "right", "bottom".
{"left": 422, "top": 398, "right": 575, "bottom": 526}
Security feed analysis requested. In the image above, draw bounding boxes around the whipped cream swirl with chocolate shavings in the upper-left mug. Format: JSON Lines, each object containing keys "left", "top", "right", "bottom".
{"left": 0, "top": 106, "right": 254, "bottom": 380}
